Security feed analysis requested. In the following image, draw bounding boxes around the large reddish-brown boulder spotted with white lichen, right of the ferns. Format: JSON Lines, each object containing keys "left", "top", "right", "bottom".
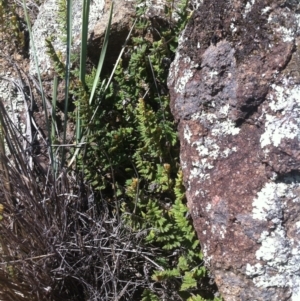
{"left": 169, "top": 0, "right": 300, "bottom": 301}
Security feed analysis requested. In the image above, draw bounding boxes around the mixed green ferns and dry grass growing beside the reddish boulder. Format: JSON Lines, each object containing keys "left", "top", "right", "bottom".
{"left": 0, "top": 0, "right": 219, "bottom": 301}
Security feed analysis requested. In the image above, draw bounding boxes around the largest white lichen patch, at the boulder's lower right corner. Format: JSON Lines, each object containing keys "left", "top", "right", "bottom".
{"left": 246, "top": 182, "right": 300, "bottom": 301}
